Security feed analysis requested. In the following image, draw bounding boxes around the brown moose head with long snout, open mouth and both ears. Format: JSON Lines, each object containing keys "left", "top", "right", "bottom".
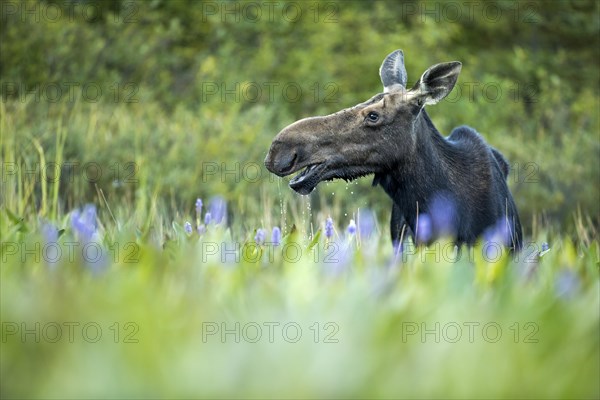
{"left": 265, "top": 50, "right": 461, "bottom": 194}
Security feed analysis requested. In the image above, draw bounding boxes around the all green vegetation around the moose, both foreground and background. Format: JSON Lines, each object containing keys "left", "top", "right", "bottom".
{"left": 0, "top": 0, "right": 600, "bottom": 398}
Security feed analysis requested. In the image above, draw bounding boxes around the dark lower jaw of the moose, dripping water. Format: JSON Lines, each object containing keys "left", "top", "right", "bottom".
{"left": 290, "top": 163, "right": 373, "bottom": 195}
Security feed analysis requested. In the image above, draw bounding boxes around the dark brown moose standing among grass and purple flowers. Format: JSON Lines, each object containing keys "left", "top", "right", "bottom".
{"left": 265, "top": 50, "right": 522, "bottom": 250}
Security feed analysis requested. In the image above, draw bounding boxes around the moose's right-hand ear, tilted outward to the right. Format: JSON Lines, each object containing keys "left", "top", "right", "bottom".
{"left": 412, "top": 61, "right": 462, "bottom": 104}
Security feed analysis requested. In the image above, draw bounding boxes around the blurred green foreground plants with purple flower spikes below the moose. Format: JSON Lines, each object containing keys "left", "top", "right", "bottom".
{"left": 1, "top": 190, "right": 600, "bottom": 398}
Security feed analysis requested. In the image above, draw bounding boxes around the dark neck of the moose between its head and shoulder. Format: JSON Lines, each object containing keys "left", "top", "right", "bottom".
{"left": 374, "top": 110, "right": 454, "bottom": 220}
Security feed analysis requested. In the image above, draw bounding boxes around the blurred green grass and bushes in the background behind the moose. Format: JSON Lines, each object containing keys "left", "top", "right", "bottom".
{"left": 0, "top": 0, "right": 600, "bottom": 233}
